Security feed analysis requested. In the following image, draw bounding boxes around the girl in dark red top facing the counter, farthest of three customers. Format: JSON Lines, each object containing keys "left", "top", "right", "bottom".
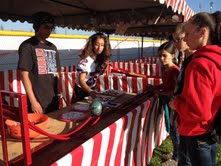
{"left": 154, "top": 41, "right": 180, "bottom": 161}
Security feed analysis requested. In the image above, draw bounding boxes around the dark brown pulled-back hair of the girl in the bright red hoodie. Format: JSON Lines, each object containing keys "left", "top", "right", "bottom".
{"left": 188, "top": 11, "right": 221, "bottom": 46}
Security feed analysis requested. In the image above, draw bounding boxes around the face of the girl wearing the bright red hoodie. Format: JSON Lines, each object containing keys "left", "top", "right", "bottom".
{"left": 184, "top": 23, "right": 202, "bottom": 50}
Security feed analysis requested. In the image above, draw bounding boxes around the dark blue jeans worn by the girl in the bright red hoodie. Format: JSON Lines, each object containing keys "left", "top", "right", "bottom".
{"left": 180, "top": 133, "right": 218, "bottom": 166}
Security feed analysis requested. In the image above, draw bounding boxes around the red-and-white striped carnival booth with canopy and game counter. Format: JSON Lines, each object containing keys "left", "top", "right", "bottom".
{"left": 0, "top": 0, "right": 193, "bottom": 166}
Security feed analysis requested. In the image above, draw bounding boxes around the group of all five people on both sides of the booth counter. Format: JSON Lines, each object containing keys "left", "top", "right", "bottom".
{"left": 18, "top": 11, "right": 221, "bottom": 166}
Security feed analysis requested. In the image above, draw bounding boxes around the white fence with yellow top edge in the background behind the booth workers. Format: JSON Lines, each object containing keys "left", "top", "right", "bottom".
{"left": 0, "top": 31, "right": 164, "bottom": 71}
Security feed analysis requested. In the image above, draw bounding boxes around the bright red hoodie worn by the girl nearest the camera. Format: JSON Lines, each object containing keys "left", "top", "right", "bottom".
{"left": 174, "top": 45, "right": 221, "bottom": 136}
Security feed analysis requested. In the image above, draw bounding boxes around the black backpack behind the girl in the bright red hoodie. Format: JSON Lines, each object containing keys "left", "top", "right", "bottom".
{"left": 211, "top": 107, "right": 221, "bottom": 144}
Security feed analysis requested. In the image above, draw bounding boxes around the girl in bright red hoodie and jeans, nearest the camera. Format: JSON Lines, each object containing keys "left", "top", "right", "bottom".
{"left": 170, "top": 12, "right": 221, "bottom": 166}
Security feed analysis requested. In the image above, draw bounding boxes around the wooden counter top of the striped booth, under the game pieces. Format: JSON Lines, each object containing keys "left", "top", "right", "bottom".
{"left": 0, "top": 94, "right": 148, "bottom": 165}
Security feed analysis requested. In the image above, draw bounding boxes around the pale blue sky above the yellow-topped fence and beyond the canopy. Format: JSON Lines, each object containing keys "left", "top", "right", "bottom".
{"left": 0, "top": 0, "right": 221, "bottom": 35}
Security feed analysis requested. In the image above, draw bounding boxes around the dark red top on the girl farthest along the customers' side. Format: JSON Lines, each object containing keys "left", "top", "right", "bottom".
{"left": 162, "top": 66, "right": 180, "bottom": 92}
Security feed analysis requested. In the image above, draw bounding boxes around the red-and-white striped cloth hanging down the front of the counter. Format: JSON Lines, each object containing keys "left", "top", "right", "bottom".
{"left": 52, "top": 98, "right": 167, "bottom": 166}
